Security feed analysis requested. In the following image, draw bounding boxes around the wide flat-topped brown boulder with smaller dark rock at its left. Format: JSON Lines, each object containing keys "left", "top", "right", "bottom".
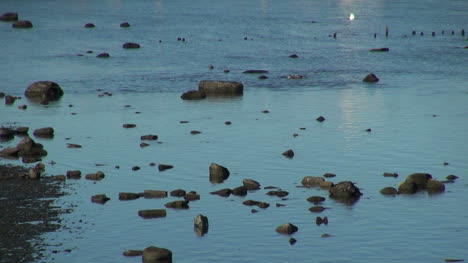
{"left": 198, "top": 80, "right": 244, "bottom": 96}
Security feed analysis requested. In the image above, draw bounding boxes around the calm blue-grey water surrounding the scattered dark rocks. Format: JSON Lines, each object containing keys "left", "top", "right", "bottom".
{"left": 0, "top": 0, "right": 468, "bottom": 263}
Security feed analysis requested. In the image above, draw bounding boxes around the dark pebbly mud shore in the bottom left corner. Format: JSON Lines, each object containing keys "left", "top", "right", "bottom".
{"left": 0, "top": 164, "right": 70, "bottom": 263}
